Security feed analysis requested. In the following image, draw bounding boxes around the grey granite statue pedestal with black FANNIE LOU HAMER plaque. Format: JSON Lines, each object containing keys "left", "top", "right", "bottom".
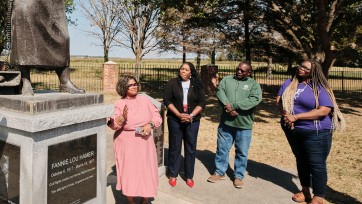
{"left": 0, "top": 93, "right": 113, "bottom": 204}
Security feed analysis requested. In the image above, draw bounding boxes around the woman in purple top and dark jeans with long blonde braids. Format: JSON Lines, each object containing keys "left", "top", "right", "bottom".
{"left": 277, "top": 60, "right": 345, "bottom": 204}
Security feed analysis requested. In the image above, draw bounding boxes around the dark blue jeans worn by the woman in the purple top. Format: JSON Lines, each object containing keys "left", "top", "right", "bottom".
{"left": 282, "top": 126, "right": 332, "bottom": 197}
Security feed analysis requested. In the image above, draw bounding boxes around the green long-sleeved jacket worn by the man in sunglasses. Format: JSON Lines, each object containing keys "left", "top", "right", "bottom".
{"left": 216, "top": 76, "right": 262, "bottom": 129}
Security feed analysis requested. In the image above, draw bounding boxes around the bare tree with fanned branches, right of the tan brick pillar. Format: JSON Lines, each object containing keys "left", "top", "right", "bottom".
{"left": 117, "top": 0, "right": 160, "bottom": 69}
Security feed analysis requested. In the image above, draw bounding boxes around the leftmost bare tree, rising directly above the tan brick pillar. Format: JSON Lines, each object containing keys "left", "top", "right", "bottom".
{"left": 79, "top": 0, "right": 123, "bottom": 62}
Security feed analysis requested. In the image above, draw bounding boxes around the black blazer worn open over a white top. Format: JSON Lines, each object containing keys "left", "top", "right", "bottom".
{"left": 163, "top": 77, "right": 206, "bottom": 121}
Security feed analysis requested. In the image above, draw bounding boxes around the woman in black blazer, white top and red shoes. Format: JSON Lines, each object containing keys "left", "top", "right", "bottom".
{"left": 163, "top": 62, "right": 205, "bottom": 188}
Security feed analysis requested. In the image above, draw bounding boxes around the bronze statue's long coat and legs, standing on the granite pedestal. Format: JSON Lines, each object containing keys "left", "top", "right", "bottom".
{"left": 10, "top": 0, "right": 84, "bottom": 95}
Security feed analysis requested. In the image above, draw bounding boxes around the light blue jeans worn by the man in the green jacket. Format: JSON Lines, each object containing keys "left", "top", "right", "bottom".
{"left": 215, "top": 124, "right": 252, "bottom": 179}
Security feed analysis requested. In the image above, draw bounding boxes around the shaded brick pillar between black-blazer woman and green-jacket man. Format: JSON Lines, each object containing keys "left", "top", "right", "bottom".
{"left": 201, "top": 64, "right": 219, "bottom": 94}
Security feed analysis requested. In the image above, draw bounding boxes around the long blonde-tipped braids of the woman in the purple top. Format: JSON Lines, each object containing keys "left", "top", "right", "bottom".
{"left": 282, "top": 59, "right": 346, "bottom": 130}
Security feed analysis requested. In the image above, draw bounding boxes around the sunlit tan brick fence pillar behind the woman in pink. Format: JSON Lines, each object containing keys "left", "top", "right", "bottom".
{"left": 103, "top": 61, "right": 119, "bottom": 92}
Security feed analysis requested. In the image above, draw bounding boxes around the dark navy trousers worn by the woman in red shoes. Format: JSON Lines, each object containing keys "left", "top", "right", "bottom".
{"left": 167, "top": 118, "right": 200, "bottom": 179}
